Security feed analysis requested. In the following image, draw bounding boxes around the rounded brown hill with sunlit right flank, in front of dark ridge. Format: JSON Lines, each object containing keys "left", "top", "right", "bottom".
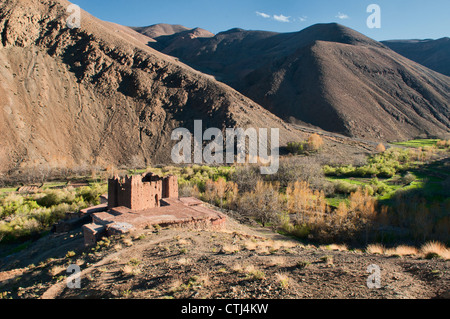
{"left": 242, "top": 41, "right": 450, "bottom": 140}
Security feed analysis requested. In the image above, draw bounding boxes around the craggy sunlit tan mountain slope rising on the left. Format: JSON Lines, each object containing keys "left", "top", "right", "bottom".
{"left": 0, "top": 0, "right": 295, "bottom": 172}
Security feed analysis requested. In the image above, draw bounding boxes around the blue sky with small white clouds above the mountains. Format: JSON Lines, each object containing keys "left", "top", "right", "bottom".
{"left": 72, "top": 0, "right": 450, "bottom": 40}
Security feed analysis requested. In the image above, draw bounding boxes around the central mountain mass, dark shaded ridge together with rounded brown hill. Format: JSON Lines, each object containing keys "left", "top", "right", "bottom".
{"left": 137, "top": 23, "right": 450, "bottom": 139}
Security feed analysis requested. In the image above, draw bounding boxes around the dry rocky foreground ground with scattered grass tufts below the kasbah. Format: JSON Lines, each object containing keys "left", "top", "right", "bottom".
{"left": 0, "top": 215, "right": 450, "bottom": 299}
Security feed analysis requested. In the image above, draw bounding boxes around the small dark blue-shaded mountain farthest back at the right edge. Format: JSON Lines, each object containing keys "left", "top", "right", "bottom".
{"left": 382, "top": 37, "right": 450, "bottom": 76}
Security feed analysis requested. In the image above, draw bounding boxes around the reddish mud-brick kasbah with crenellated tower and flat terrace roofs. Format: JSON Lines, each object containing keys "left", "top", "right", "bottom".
{"left": 55, "top": 173, "right": 226, "bottom": 245}
